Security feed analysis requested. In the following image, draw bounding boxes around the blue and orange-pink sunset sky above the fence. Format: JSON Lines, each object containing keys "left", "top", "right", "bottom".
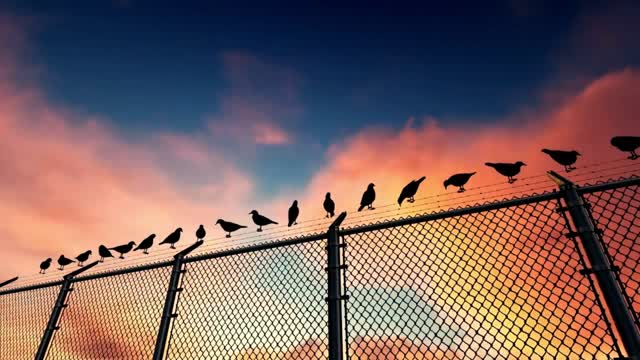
{"left": 0, "top": 0, "right": 640, "bottom": 280}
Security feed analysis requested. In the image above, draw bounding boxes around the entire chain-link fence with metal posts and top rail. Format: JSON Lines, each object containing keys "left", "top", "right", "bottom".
{"left": 0, "top": 174, "right": 640, "bottom": 359}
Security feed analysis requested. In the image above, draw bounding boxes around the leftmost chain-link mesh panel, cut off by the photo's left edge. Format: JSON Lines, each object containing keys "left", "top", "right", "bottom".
{"left": 0, "top": 285, "right": 60, "bottom": 360}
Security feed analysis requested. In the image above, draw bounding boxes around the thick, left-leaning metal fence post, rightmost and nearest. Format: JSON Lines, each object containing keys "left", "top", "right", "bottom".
{"left": 549, "top": 171, "right": 640, "bottom": 359}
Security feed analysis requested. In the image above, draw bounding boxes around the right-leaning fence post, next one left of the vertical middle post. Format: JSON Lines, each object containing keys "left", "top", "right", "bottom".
{"left": 153, "top": 241, "right": 203, "bottom": 360}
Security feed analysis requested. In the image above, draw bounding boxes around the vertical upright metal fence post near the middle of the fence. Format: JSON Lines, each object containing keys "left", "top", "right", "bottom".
{"left": 326, "top": 212, "right": 347, "bottom": 360}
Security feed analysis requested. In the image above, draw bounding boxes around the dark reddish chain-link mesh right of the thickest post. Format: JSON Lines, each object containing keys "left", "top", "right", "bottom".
{"left": 584, "top": 185, "right": 640, "bottom": 326}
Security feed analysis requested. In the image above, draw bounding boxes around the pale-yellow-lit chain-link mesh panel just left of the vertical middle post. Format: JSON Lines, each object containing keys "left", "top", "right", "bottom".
{"left": 168, "top": 240, "right": 328, "bottom": 359}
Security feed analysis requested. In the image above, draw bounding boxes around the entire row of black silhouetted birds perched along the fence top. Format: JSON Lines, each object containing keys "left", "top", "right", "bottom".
{"left": 32, "top": 136, "right": 640, "bottom": 274}
